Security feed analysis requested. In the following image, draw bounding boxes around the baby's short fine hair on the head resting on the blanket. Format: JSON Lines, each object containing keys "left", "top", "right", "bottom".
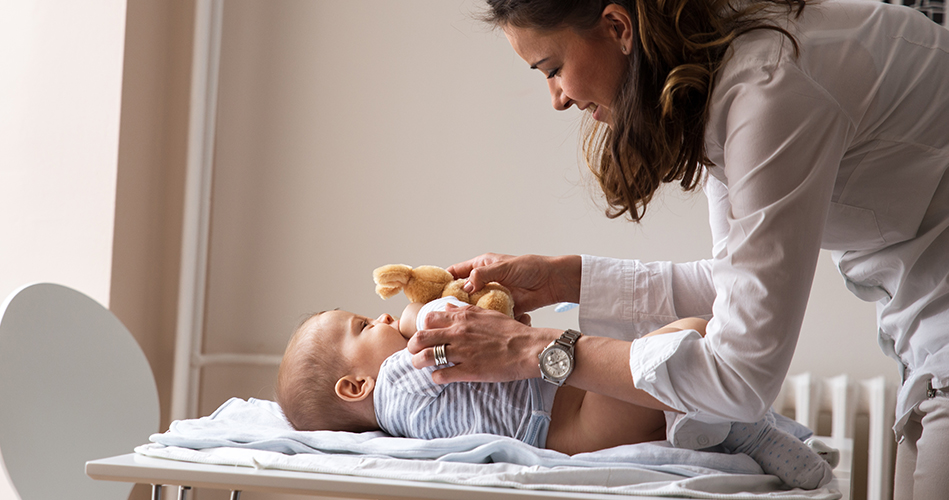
{"left": 276, "top": 311, "right": 365, "bottom": 432}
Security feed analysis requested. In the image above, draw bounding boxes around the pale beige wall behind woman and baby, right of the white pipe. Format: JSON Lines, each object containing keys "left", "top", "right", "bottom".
{"left": 194, "top": 0, "right": 896, "bottom": 426}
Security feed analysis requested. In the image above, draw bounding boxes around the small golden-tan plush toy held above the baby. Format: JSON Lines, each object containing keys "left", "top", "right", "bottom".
{"left": 372, "top": 264, "right": 514, "bottom": 317}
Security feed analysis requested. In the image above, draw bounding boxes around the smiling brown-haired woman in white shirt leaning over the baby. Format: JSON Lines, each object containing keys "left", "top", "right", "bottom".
{"left": 409, "top": 0, "right": 949, "bottom": 498}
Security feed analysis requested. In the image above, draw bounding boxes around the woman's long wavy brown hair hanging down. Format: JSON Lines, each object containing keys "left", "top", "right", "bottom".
{"left": 482, "top": 0, "right": 806, "bottom": 221}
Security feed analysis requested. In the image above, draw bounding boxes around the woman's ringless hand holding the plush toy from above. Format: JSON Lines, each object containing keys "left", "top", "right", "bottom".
{"left": 448, "top": 253, "right": 583, "bottom": 317}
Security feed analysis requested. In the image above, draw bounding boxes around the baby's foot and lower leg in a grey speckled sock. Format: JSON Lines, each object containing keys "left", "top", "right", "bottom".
{"left": 722, "top": 414, "right": 833, "bottom": 490}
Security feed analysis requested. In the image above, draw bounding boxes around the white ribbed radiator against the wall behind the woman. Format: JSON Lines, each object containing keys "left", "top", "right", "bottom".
{"left": 774, "top": 373, "right": 896, "bottom": 500}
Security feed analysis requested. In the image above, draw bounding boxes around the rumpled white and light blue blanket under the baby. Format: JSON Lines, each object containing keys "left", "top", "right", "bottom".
{"left": 136, "top": 398, "right": 840, "bottom": 500}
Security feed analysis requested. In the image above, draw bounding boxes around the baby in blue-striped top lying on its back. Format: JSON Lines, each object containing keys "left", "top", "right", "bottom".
{"left": 277, "top": 297, "right": 832, "bottom": 489}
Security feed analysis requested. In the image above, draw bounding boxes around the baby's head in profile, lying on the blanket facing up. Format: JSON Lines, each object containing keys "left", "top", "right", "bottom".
{"left": 276, "top": 310, "right": 408, "bottom": 432}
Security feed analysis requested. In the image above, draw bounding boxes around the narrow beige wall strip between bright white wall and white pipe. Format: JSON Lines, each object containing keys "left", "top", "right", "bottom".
{"left": 110, "top": 0, "right": 194, "bottom": 438}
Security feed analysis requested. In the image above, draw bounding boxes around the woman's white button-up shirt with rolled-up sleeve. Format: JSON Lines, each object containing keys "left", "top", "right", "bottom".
{"left": 580, "top": 0, "right": 949, "bottom": 436}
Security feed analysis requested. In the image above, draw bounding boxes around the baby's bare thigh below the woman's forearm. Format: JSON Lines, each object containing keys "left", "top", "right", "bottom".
{"left": 547, "top": 386, "right": 666, "bottom": 455}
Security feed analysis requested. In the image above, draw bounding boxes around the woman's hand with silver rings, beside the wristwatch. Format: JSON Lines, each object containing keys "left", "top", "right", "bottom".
{"left": 408, "top": 304, "right": 561, "bottom": 384}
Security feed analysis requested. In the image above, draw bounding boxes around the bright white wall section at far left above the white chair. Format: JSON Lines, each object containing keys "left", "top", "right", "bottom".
{"left": 0, "top": 0, "right": 125, "bottom": 305}
